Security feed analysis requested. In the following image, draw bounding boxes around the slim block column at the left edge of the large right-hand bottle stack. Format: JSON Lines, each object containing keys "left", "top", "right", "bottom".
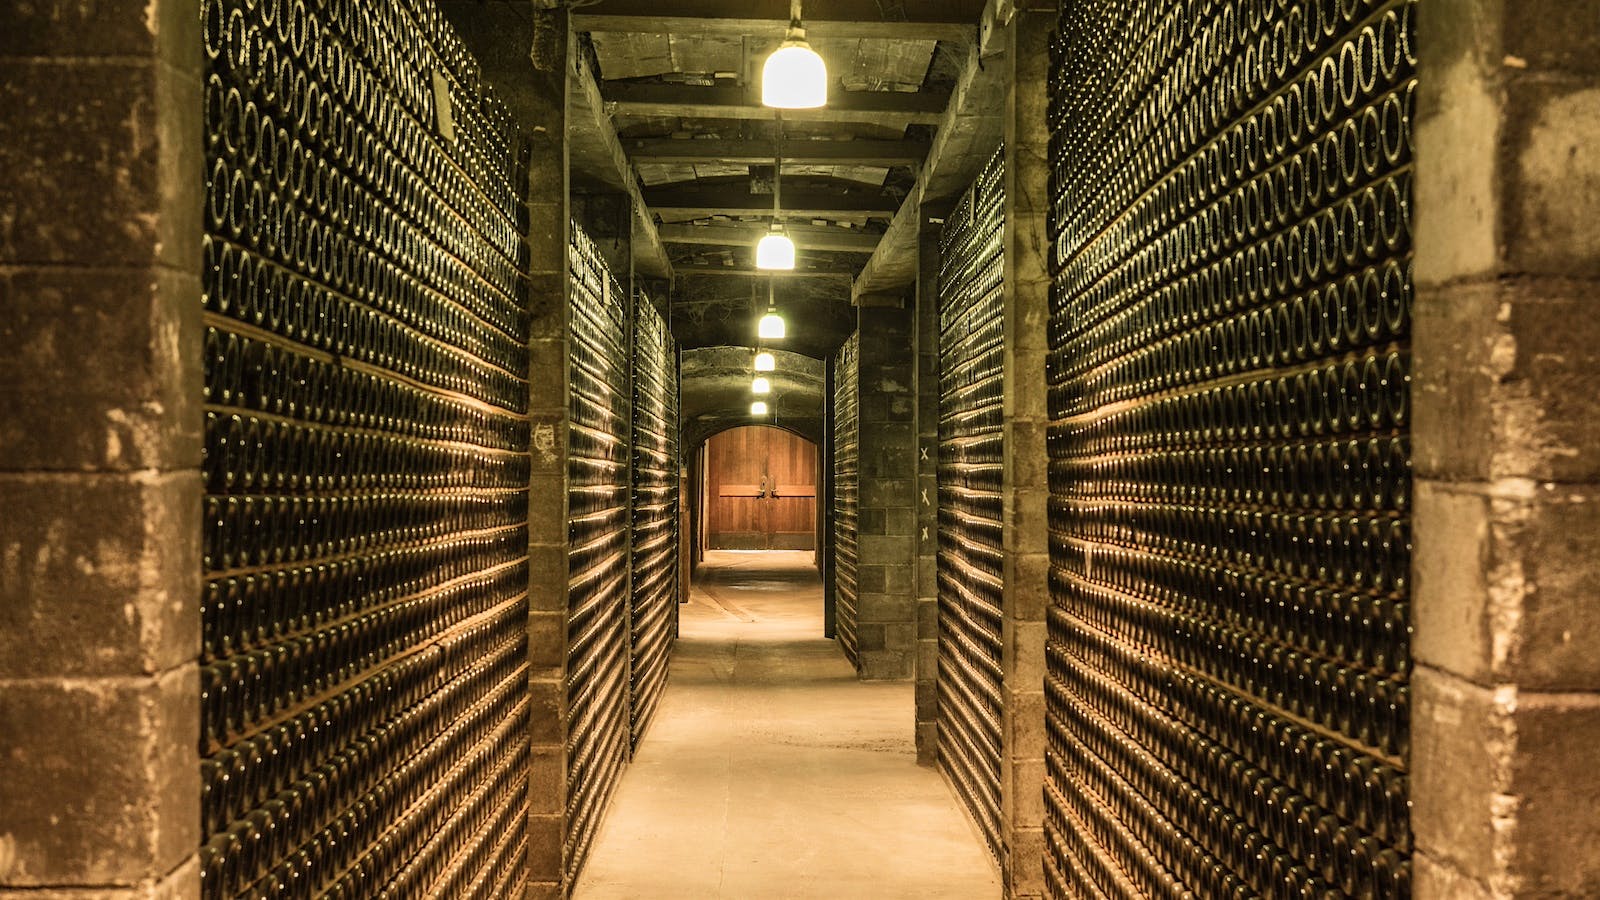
{"left": 1000, "top": 10, "right": 1056, "bottom": 897}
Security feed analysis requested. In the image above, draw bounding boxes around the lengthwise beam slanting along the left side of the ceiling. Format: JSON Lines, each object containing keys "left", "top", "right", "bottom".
{"left": 566, "top": 52, "right": 672, "bottom": 279}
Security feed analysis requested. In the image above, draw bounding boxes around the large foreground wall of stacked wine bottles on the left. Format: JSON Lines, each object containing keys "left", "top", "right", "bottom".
{"left": 198, "top": 0, "right": 531, "bottom": 900}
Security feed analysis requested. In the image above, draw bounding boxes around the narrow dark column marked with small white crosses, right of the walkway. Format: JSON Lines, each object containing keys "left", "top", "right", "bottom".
{"left": 915, "top": 210, "right": 939, "bottom": 755}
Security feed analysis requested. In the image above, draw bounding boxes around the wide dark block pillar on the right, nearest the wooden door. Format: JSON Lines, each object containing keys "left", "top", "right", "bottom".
{"left": 856, "top": 307, "right": 917, "bottom": 679}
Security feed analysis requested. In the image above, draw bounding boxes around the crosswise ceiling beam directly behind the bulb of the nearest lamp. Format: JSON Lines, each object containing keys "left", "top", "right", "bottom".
{"left": 602, "top": 82, "right": 950, "bottom": 128}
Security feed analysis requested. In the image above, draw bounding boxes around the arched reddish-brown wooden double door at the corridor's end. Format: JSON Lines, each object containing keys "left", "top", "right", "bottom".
{"left": 706, "top": 424, "right": 818, "bottom": 549}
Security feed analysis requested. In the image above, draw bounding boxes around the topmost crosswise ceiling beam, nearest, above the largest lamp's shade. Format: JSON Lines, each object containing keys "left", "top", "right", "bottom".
{"left": 573, "top": 13, "right": 978, "bottom": 43}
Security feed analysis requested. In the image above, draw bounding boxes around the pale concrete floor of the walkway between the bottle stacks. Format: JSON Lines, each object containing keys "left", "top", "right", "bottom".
{"left": 574, "top": 552, "right": 1000, "bottom": 900}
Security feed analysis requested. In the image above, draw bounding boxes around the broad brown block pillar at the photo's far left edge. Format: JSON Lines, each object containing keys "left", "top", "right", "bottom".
{"left": 0, "top": 0, "right": 205, "bottom": 900}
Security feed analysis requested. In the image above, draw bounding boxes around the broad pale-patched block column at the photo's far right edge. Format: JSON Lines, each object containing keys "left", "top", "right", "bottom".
{"left": 1411, "top": 0, "right": 1600, "bottom": 900}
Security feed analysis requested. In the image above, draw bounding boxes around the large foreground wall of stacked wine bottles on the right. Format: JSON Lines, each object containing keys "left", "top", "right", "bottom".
{"left": 1046, "top": 0, "right": 1418, "bottom": 898}
